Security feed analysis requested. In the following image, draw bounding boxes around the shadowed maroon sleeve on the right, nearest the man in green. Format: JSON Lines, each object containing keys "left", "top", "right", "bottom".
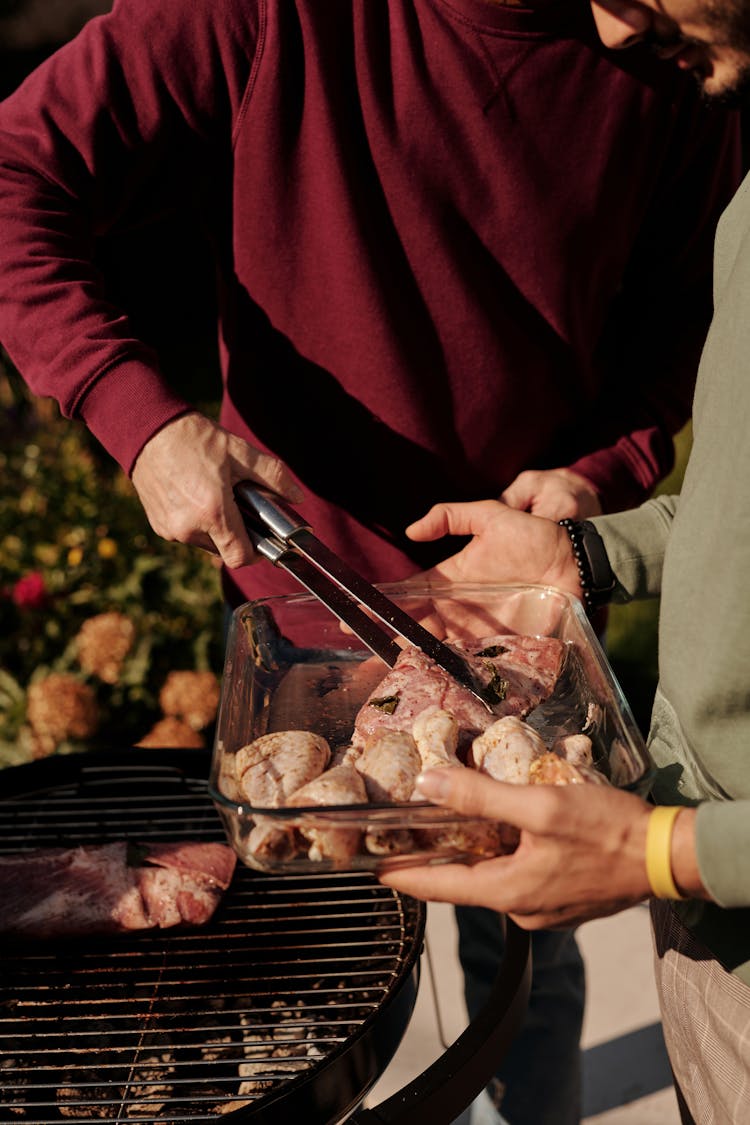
{"left": 570, "top": 96, "right": 742, "bottom": 512}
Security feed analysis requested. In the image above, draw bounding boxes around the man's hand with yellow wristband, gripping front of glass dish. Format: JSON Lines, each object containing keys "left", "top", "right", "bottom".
{"left": 379, "top": 767, "right": 656, "bottom": 929}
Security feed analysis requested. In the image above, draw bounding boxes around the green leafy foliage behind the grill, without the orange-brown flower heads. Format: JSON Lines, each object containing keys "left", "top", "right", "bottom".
{"left": 0, "top": 358, "right": 223, "bottom": 764}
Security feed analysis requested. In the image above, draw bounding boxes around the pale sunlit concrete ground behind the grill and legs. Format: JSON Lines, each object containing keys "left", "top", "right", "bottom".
{"left": 367, "top": 905, "right": 679, "bottom": 1125}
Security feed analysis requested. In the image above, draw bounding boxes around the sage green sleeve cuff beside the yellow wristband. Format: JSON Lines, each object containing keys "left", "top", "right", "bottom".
{"left": 695, "top": 801, "right": 750, "bottom": 908}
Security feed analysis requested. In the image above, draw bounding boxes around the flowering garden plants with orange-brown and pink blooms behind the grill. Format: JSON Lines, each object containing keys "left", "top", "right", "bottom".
{"left": 0, "top": 357, "right": 224, "bottom": 765}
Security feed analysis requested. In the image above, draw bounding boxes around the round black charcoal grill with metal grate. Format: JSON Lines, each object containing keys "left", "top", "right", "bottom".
{"left": 0, "top": 747, "right": 528, "bottom": 1125}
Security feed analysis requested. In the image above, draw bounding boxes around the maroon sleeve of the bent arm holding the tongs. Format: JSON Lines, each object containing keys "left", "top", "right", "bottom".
{"left": 0, "top": 0, "right": 257, "bottom": 473}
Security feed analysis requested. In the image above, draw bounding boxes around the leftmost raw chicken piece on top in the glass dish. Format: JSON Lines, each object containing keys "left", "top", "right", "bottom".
{"left": 235, "top": 730, "right": 331, "bottom": 809}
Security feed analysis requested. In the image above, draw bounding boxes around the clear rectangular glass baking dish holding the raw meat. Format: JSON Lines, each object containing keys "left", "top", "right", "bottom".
{"left": 209, "top": 584, "right": 652, "bottom": 873}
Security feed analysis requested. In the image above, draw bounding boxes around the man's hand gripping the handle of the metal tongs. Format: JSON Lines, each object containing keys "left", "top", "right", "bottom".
{"left": 133, "top": 412, "right": 301, "bottom": 568}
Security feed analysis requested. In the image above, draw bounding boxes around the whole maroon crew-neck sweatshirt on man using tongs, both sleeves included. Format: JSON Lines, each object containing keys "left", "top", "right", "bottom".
{"left": 0, "top": 0, "right": 739, "bottom": 600}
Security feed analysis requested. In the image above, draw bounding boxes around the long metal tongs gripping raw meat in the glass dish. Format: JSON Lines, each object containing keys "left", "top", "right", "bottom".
{"left": 234, "top": 480, "right": 489, "bottom": 708}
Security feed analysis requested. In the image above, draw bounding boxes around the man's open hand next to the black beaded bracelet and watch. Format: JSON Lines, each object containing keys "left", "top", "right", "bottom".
{"left": 406, "top": 500, "right": 581, "bottom": 597}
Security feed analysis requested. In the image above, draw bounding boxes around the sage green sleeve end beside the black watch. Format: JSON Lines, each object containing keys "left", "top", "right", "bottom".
{"left": 591, "top": 496, "right": 679, "bottom": 602}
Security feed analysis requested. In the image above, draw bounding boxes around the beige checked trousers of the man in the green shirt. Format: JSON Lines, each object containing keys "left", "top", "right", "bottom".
{"left": 651, "top": 900, "right": 750, "bottom": 1125}
